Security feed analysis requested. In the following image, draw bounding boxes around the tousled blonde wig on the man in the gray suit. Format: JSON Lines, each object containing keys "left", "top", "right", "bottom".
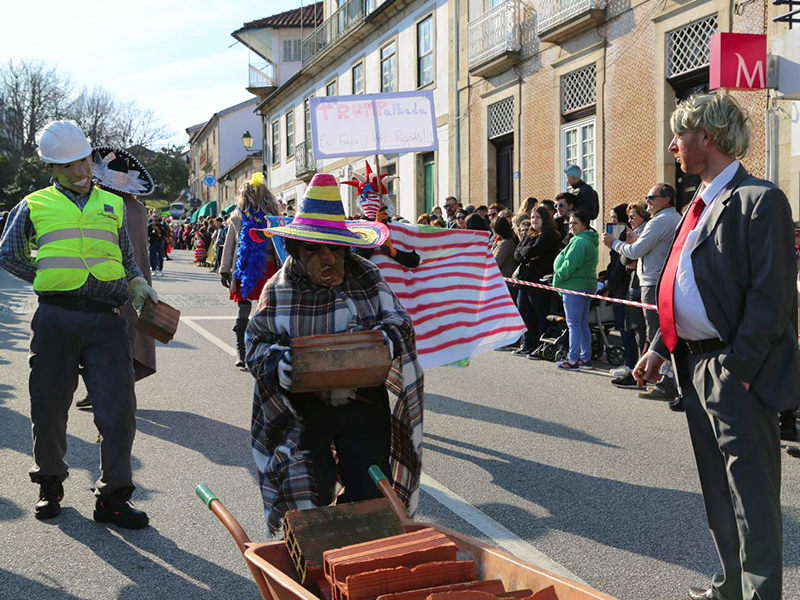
{"left": 670, "top": 92, "right": 750, "bottom": 158}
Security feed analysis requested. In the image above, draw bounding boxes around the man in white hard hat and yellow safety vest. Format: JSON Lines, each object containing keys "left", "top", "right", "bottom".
{"left": 0, "top": 121, "right": 158, "bottom": 529}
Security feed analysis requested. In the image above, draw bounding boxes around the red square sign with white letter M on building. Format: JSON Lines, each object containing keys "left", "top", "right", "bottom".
{"left": 708, "top": 33, "right": 767, "bottom": 90}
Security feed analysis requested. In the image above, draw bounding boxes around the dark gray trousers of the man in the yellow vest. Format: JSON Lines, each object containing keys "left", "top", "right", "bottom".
{"left": 29, "top": 304, "right": 136, "bottom": 495}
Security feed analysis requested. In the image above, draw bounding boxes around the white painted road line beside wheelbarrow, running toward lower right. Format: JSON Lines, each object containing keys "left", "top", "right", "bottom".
{"left": 420, "top": 473, "right": 586, "bottom": 585}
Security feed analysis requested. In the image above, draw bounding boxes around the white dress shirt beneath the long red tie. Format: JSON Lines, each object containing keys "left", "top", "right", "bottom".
{"left": 673, "top": 160, "right": 739, "bottom": 341}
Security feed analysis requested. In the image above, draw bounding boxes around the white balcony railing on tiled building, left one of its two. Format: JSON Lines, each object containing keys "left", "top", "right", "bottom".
{"left": 469, "top": 0, "right": 521, "bottom": 69}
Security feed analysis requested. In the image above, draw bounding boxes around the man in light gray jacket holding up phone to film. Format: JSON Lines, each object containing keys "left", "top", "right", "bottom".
{"left": 603, "top": 183, "right": 681, "bottom": 401}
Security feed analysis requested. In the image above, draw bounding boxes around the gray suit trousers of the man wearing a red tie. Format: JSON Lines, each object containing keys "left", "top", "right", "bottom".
{"left": 675, "top": 351, "right": 783, "bottom": 600}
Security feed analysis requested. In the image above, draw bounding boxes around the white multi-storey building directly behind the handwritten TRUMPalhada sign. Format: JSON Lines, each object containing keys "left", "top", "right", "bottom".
{"left": 237, "top": 0, "right": 454, "bottom": 219}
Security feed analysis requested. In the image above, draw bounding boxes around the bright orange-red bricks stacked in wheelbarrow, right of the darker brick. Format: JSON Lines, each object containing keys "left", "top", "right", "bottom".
{"left": 318, "top": 528, "right": 557, "bottom": 600}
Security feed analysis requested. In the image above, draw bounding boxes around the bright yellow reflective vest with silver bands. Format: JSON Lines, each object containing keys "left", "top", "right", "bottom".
{"left": 26, "top": 186, "right": 125, "bottom": 292}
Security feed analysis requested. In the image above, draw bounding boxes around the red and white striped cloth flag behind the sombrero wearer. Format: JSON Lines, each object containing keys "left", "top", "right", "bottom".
{"left": 372, "top": 223, "right": 525, "bottom": 369}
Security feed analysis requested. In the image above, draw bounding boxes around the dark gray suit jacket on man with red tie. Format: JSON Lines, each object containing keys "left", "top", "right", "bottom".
{"left": 653, "top": 167, "right": 800, "bottom": 411}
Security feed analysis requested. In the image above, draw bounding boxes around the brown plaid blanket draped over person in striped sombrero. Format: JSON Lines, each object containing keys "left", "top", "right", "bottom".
{"left": 245, "top": 252, "right": 424, "bottom": 533}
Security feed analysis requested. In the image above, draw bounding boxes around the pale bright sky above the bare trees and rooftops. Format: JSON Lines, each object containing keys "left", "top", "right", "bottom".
{"left": 0, "top": 0, "right": 294, "bottom": 144}
